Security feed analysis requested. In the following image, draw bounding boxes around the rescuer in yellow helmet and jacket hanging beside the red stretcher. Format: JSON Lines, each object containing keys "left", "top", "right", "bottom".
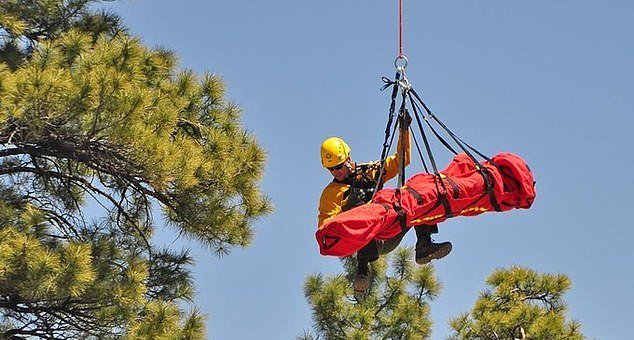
{"left": 318, "top": 118, "right": 451, "bottom": 295}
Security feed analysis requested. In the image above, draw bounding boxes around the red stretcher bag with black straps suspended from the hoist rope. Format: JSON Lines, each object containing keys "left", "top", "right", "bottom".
{"left": 316, "top": 153, "right": 535, "bottom": 256}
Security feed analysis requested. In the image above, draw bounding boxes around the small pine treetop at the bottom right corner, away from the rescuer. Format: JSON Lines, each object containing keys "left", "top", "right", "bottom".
{"left": 450, "top": 267, "right": 585, "bottom": 340}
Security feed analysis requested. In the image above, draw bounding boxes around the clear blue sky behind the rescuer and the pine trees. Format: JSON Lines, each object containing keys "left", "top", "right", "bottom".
{"left": 101, "top": 0, "right": 634, "bottom": 339}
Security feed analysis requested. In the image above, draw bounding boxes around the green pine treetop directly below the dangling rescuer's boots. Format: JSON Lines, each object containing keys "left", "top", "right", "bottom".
{"left": 298, "top": 248, "right": 441, "bottom": 340}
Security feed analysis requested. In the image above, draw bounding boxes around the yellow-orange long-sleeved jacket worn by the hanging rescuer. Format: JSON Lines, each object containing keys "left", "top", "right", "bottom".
{"left": 317, "top": 132, "right": 411, "bottom": 228}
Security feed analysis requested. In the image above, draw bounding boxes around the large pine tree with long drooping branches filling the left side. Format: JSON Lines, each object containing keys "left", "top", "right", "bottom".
{"left": 0, "top": 0, "right": 272, "bottom": 339}
